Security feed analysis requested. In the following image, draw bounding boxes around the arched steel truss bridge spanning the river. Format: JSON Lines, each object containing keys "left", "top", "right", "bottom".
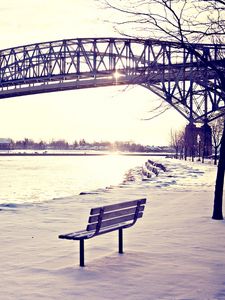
{"left": 0, "top": 38, "right": 225, "bottom": 123}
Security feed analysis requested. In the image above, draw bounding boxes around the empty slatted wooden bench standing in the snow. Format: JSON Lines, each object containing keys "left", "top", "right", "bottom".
{"left": 59, "top": 199, "right": 146, "bottom": 267}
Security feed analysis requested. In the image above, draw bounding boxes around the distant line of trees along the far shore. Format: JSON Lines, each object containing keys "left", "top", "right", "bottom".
{"left": 10, "top": 138, "right": 171, "bottom": 152}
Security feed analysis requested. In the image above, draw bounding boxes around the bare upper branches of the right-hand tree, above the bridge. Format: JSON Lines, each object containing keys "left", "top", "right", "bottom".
{"left": 102, "top": 0, "right": 225, "bottom": 43}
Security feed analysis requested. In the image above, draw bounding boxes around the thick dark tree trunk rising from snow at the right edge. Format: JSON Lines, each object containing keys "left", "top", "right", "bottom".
{"left": 212, "top": 122, "right": 225, "bottom": 220}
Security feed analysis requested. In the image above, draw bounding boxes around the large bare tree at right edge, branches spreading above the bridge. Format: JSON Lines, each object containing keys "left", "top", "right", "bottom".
{"left": 103, "top": 0, "right": 225, "bottom": 220}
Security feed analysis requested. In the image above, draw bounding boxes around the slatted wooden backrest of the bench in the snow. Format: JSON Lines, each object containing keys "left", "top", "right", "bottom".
{"left": 86, "top": 199, "right": 146, "bottom": 234}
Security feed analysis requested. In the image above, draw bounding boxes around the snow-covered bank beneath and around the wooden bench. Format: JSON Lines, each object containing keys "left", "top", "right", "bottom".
{"left": 0, "top": 159, "right": 225, "bottom": 300}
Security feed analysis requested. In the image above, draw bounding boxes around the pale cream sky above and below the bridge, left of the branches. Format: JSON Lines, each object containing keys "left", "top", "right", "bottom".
{"left": 0, "top": 0, "right": 186, "bottom": 145}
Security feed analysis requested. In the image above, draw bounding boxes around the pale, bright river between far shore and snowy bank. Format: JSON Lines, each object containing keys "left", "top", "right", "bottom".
{"left": 0, "top": 155, "right": 147, "bottom": 205}
